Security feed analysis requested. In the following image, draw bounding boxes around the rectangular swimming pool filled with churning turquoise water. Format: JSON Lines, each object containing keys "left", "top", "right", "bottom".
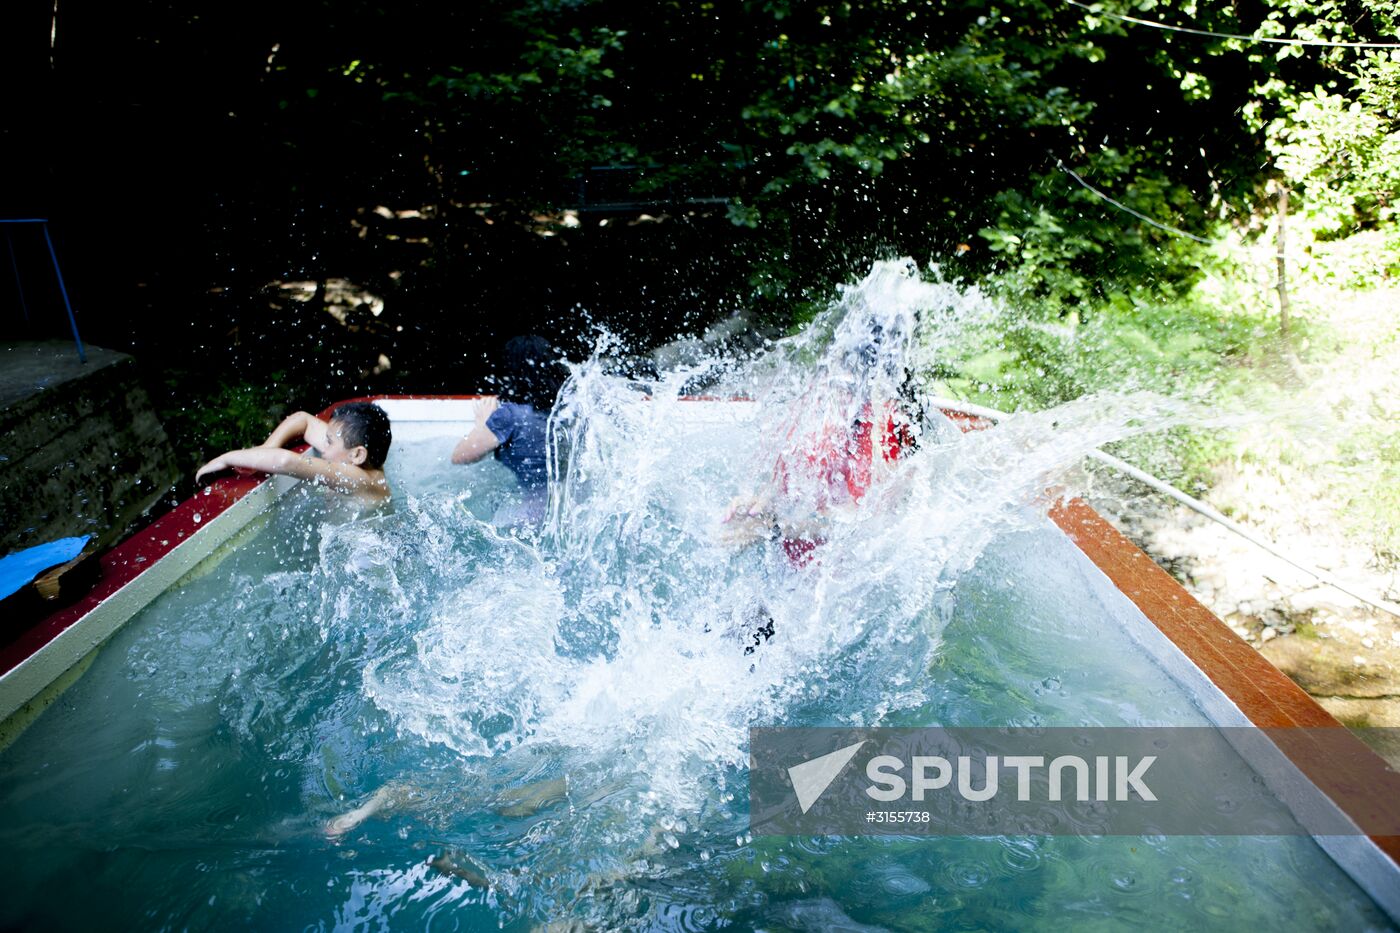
{"left": 0, "top": 399, "right": 1396, "bottom": 930}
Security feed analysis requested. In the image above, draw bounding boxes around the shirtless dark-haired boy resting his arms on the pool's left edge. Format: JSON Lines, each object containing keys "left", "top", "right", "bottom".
{"left": 195, "top": 402, "right": 393, "bottom": 506}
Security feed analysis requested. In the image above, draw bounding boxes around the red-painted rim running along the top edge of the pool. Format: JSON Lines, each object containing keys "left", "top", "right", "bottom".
{"left": 0, "top": 395, "right": 1400, "bottom": 866}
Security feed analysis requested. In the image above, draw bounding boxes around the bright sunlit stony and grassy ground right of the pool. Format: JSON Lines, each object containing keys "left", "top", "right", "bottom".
{"left": 1091, "top": 281, "right": 1400, "bottom": 766}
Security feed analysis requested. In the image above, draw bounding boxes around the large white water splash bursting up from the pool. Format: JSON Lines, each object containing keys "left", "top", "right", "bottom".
{"left": 287, "top": 262, "right": 1204, "bottom": 909}
